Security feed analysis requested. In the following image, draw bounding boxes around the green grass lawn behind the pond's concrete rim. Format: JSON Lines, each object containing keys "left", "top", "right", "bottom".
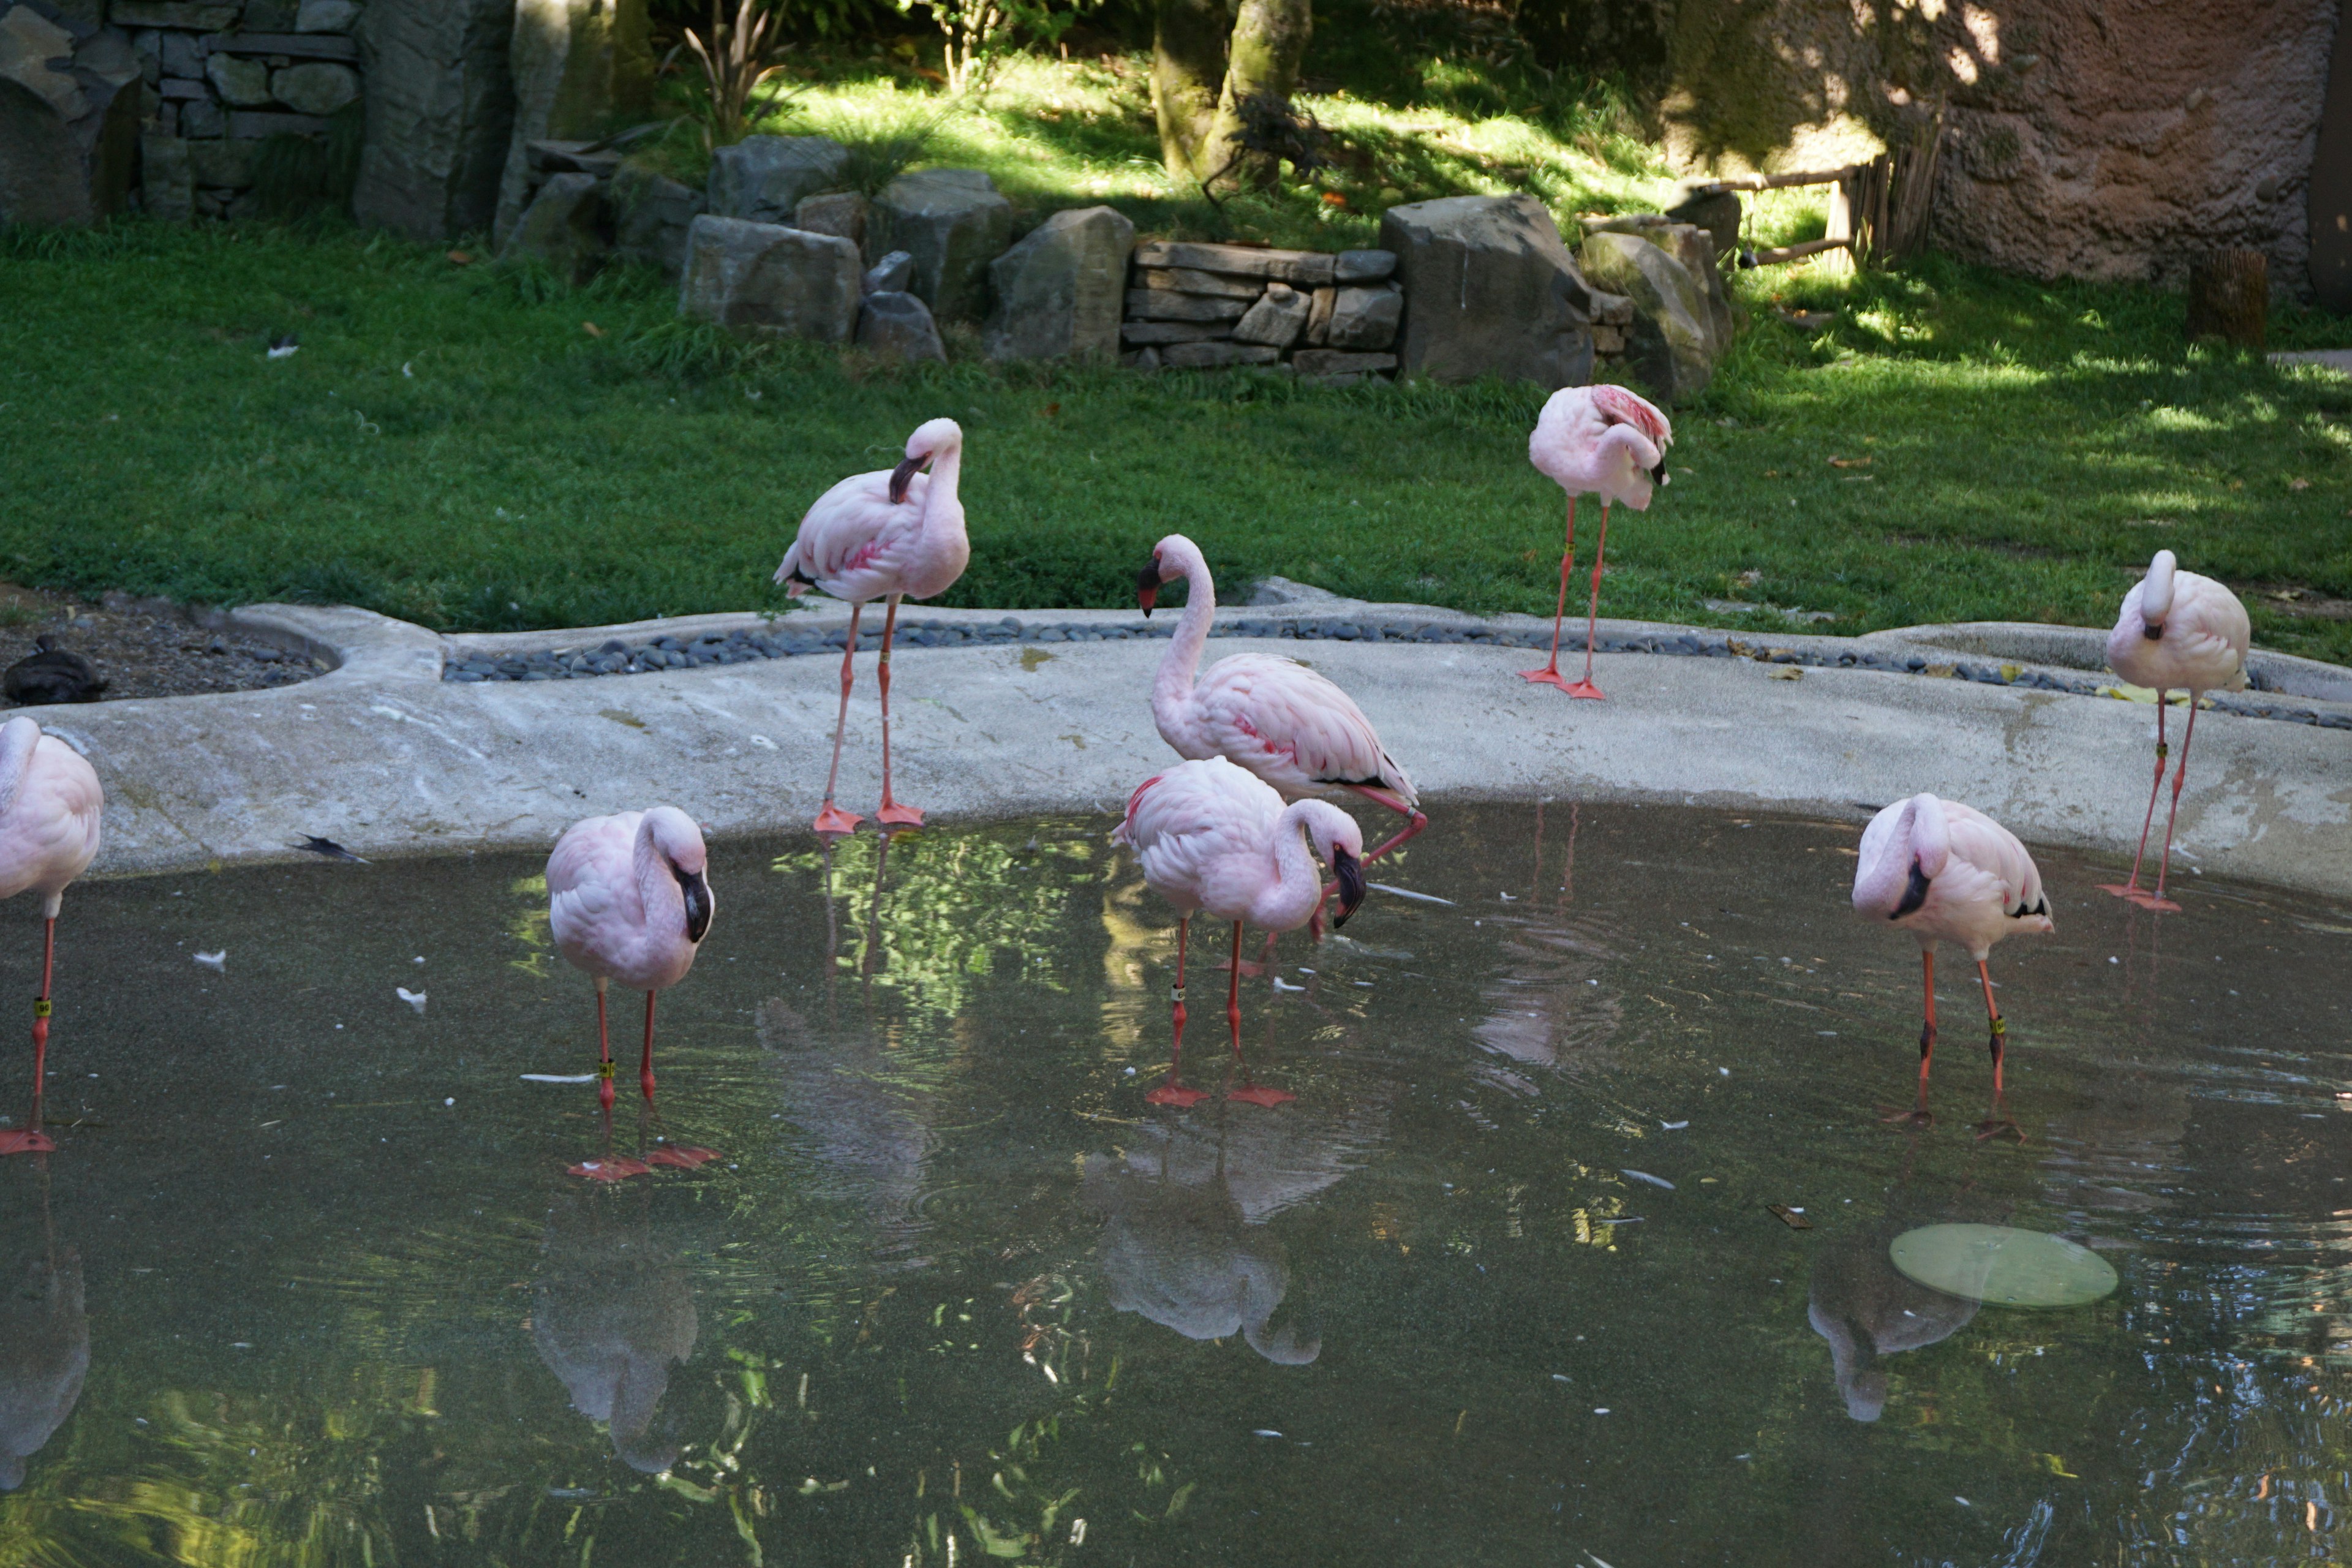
{"left": 0, "top": 66, "right": 2352, "bottom": 663}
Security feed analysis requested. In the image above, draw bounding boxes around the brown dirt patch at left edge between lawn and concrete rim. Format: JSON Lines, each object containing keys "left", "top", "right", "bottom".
{"left": 0, "top": 583, "right": 327, "bottom": 707}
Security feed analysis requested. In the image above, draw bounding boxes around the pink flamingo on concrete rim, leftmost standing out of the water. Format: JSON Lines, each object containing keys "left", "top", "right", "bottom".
{"left": 776, "top": 418, "right": 971, "bottom": 832}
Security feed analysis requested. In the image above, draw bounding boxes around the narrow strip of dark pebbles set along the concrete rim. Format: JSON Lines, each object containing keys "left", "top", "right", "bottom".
{"left": 442, "top": 616, "right": 2352, "bottom": 729}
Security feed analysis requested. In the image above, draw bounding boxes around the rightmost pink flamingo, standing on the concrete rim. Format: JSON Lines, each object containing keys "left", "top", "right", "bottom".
{"left": 2100, "top": 550, "right": 2253, "bottom": 914}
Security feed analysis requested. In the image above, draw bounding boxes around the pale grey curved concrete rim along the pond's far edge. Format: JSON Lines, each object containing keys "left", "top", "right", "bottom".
{"left": 36, "top": 600, "right": 2352, "bottom": 895}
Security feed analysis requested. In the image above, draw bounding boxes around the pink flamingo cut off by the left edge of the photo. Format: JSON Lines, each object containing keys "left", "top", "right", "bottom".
{"left": 0, "top": 717, "right": 106, "bottom": 1154}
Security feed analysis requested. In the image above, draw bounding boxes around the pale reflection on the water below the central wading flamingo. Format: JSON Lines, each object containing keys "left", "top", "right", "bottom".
{"left": 1084, "top": 1093, "right": 1388, "bottom": 1366}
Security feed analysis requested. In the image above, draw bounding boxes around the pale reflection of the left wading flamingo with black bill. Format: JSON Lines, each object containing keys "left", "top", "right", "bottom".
{"left": 532, "top": 1192, "right": 698, "bottom": 1474}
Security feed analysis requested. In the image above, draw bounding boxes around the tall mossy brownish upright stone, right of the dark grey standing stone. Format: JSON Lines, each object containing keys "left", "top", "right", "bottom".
{"left": 494, "top": 0, "right": 654, "bottom": 244}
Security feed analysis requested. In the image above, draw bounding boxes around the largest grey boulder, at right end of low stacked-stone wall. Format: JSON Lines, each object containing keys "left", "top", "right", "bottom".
{"left": 1381, "top": 195, "right": 1593, "bottom": 390}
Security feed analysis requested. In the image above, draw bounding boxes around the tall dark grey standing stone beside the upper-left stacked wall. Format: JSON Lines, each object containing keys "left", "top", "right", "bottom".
{"left": 350, "top": 0, "right": 515, "bottom": 239}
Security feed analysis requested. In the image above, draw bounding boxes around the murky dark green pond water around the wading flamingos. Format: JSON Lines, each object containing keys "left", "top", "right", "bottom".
{"left": 0, "top": 804, "right": 2352, "bottom": 1568}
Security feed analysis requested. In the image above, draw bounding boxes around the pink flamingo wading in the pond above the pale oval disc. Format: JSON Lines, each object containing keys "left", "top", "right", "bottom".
{"left": 1853, "top": 794, "right": 2056, "bottom": 1138}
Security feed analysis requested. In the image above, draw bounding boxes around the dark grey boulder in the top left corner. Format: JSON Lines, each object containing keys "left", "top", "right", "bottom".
{"left": 0, "top": 0, "right": 141, "bottom": 224}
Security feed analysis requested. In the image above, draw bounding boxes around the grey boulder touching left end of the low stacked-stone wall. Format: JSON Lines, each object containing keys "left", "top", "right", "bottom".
{"left": 981, "top": 207, "right": 1136, "bottom": 360}
